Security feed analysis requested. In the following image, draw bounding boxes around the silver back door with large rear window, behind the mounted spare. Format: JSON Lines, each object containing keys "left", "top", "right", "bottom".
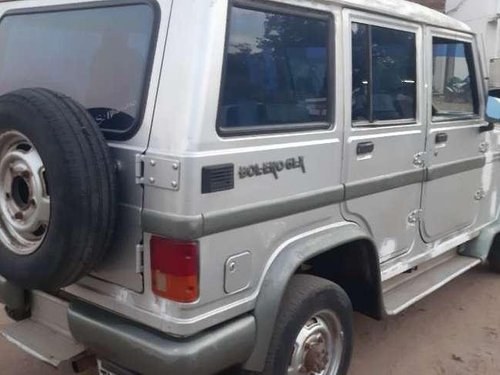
{"left": 0, "top": 0, "right": 171, "bottom": 292}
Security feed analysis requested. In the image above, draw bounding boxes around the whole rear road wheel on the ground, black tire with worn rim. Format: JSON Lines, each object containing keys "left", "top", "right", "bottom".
{"left": 262, "top": 275, "right": 353, "bottom": 375}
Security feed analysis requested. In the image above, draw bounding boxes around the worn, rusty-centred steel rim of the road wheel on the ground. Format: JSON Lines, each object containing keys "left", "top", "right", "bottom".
{"left": 287, "top": 310, "right": 344, "bottom": 375}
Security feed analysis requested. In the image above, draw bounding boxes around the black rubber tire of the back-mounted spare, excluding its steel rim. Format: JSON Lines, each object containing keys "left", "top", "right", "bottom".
{"left": 0, "top": 88, "right": 116, "bottom": 290}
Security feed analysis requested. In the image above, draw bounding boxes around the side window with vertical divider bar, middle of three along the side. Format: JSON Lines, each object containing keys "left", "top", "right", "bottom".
{"left": 352, "top": 23, "right": 417, "bottom": 123}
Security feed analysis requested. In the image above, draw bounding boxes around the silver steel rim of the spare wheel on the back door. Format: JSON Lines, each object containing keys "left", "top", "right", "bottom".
{"left": 0, "top": 131, "right": 50, "bottom": 255}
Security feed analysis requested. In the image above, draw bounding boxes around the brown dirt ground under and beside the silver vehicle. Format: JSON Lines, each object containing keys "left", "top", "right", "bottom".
{"left": 0, "top": 268, "right": 500, "bottom": 375}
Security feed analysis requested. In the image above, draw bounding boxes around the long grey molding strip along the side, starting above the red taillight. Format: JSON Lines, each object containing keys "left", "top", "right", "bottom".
{"left": 142, "top": 156, "right": 486, "bottom": 240}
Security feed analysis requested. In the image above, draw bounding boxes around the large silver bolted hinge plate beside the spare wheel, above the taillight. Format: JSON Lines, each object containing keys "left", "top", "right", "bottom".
{"left": 135, "top": 154, "right": 181, "bottom": 191}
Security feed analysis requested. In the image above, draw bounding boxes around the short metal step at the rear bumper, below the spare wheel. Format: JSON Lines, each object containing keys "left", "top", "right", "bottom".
{"left": 1, "top": 292, "right": 85, "bottom": 371}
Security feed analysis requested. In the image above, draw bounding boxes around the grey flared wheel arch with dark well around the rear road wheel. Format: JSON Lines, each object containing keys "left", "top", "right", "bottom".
{"left": 243, "top": 223, "right": 383, "bottom": 371}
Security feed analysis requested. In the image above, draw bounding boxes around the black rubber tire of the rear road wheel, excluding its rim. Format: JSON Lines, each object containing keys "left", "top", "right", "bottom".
{"left": 262, "top": 275, "right": 353, "bottom": 375}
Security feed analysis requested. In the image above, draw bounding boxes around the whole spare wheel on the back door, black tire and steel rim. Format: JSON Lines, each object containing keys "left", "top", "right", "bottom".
{"left": 0, "top": 88, "right": 116, "bottom": 290}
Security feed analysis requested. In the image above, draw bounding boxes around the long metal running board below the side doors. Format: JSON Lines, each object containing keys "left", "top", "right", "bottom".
{"left": 383, "top": 251, "right": 481, "bottom": 315}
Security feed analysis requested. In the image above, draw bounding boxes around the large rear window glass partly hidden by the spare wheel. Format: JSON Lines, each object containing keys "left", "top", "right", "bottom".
{"left": 0, "top": 5, "right": 154, "bottom": 137}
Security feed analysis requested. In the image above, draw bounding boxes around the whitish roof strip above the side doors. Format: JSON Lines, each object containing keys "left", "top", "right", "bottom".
{"left": 298, "top": 0, "right": 472, "bottom": 33}
